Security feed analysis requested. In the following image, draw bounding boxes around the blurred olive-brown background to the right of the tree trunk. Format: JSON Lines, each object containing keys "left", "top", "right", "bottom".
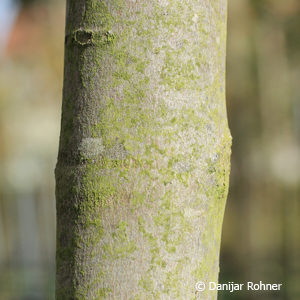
{"left": 219, "top": 0, "right": 300, "bottom": 300}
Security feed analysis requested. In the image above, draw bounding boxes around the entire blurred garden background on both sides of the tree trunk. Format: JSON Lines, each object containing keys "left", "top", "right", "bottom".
{"left": 0, "top": 0, "right": 300, "bottom": 300}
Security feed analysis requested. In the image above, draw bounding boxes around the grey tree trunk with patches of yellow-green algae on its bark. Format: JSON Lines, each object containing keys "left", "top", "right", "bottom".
{"left": 56, "top": 0, "right": 231, "bottom": 300}
